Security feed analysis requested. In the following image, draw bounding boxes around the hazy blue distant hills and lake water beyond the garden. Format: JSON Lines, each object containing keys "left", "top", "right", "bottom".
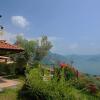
{"left": 43, "top": 52, "right": 100, "bottom": 75}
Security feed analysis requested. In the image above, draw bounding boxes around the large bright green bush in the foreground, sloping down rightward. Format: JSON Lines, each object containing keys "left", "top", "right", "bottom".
{"left": 19, "top": 68, "right": 99, "bottom": 100}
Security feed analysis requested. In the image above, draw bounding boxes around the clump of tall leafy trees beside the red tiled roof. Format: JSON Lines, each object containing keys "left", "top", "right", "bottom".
{"left": 14, "top": 36, "right": 52, "bottom": 71}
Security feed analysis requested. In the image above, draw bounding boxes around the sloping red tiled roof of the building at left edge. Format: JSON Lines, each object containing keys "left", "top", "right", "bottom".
{"left": 0, "top": 40, "right": 23, "bottom": 51}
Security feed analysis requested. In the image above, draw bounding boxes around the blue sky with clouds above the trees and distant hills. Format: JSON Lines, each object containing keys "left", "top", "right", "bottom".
{"left": 0, "top": 0, "right": 100, "bottom": 55}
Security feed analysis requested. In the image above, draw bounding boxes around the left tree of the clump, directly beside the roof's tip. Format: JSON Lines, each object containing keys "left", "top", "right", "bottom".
{"left": 15, "top": 36, "right": 37, "bottom": 64}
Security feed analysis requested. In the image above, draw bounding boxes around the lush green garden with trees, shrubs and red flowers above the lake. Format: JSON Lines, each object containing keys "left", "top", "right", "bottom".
{"left": 0, "top": 36, "right": 100, "bottom": 100}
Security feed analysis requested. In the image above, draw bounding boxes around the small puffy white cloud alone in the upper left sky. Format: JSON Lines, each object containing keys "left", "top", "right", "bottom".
{"left": 11, "top": 16, "right": 29, "bottom": 28}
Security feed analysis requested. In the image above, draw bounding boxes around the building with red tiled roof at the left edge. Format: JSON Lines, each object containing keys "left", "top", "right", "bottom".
{"left": 0, "top": 40, "right": 24, "bottom": 63}
